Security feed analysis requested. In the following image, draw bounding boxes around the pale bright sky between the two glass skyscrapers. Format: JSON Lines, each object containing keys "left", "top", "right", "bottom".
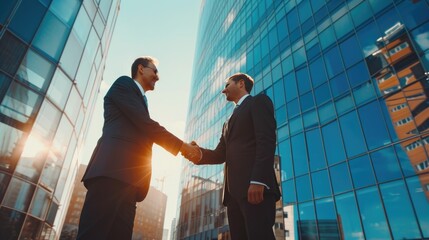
{"left": 81, "top": 0, "right": 201, "bottom": 236}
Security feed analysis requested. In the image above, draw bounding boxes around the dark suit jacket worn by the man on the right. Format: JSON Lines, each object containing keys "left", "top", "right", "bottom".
{"left": 198, "top": 95, "right": 280, "bottom": 205}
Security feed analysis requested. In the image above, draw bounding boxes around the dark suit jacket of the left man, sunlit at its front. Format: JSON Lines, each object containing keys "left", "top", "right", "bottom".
{"left": 82, "top": 76, "right": 183, "bottom": 201}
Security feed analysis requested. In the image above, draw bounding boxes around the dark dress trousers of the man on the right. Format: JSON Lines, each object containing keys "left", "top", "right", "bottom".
{"left": 227, "top": 194, "right": 276, "bottom": 240}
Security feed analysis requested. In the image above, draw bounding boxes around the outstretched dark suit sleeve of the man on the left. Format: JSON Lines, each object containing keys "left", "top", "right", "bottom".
{"left": 106, "top": 77, "right": 183, "bottom": 155}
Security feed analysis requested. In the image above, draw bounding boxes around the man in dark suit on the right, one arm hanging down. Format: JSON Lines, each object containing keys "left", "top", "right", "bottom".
{"left": 184, "top": 73, "right": 280, "bottom": 240}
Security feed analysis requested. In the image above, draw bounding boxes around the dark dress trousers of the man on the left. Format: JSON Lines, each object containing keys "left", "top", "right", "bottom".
{"left": 77, "top": 177, "right": 137, "bottom": 240}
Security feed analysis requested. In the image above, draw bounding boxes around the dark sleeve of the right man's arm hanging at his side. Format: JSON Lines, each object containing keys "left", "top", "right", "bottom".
{"left": 251, "top": 95, "right": 276, "bottom": 183}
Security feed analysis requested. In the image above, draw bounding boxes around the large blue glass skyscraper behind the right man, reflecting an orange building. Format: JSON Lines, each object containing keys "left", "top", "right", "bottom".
{"left": 176, "top": 0, "right": 429, "bottom": 240}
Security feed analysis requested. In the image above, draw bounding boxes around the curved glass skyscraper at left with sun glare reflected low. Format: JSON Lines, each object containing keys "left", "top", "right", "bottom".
{"left": 0, "top": 0, "right": 120, "bottom": 239}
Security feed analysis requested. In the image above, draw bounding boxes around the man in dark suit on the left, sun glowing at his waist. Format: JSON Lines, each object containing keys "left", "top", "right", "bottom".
{"left": 77, "top": 57, "right": 196, "bottom": 240}
